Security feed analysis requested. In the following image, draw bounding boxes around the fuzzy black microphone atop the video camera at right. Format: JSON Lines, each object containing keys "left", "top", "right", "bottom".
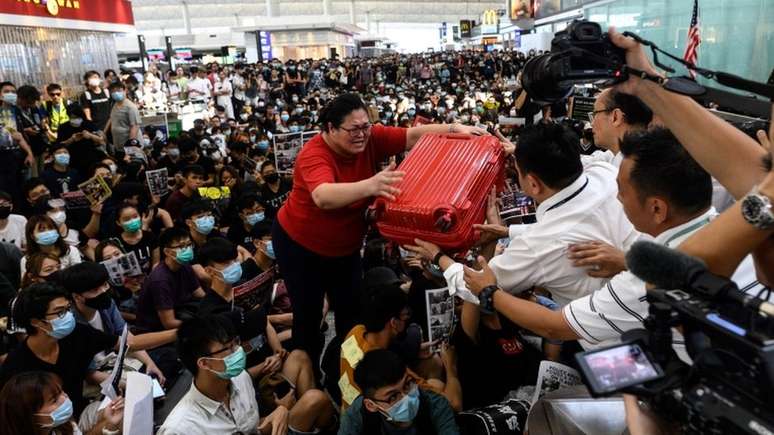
{"left": 626, "top": 241, "right": 774, "bottom": 316}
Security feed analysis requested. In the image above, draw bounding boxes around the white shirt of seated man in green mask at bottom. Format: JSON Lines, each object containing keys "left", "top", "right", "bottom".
{"left": 157, "top": 371, "right": 260, "bottom": 435}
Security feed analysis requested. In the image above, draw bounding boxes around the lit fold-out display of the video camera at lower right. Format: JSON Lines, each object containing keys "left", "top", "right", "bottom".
{"left": 583, "top": 344, "right": 661, "bottom": 391}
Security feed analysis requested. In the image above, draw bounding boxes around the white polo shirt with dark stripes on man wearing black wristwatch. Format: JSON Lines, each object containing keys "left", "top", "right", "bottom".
{"left": 562, "top": 208, "right": 764, "bottom": 349}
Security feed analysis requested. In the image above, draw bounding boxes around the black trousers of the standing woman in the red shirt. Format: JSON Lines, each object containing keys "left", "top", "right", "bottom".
{"left": 272, "top": 220, "right": 362, "bottom": 372}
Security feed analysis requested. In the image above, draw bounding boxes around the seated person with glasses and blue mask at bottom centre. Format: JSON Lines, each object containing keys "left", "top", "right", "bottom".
{"left": 339, "top": 349, "right": 459, "bottom": 435}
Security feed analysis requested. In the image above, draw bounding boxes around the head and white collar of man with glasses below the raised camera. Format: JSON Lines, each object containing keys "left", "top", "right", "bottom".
{"left": 581, "top": 89, "right": 653, "bottom": 168}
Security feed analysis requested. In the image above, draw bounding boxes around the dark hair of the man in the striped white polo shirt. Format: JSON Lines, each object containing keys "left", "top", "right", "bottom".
{"left": 621, "top": 127, "right": 712, "bottom": 216}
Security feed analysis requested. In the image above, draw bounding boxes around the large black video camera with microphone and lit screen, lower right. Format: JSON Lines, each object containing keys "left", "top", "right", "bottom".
{"left": 575, "top": 242, "right": 774, "bottom": 434}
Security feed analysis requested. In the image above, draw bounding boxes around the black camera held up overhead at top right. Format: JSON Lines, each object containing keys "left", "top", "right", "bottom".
{"left": 521, "top": 20, "right": 628, "bottom": 103}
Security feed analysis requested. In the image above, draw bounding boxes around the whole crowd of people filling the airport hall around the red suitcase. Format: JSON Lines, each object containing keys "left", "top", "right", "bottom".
{"left": 0, "top": 27, "right": 774, "bottom": 435}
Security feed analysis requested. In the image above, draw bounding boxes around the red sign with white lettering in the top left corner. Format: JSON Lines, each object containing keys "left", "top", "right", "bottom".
{"left": 0, "top": 0, "right": 134, "bottom": 32}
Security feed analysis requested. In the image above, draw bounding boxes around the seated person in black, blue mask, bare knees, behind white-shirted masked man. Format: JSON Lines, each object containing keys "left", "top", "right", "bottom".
{"left": 199, "top": 239, "right": 315, "bottom": 398}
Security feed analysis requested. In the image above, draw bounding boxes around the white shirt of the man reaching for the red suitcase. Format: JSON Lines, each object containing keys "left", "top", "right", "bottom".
{"left": 444, "top": 162, "right": 641, "bottom": 306}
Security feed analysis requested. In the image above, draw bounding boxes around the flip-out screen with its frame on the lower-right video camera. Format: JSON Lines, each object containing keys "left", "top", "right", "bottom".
{"left": 575, "top": 342, "right": 664, "bottom": 396}
